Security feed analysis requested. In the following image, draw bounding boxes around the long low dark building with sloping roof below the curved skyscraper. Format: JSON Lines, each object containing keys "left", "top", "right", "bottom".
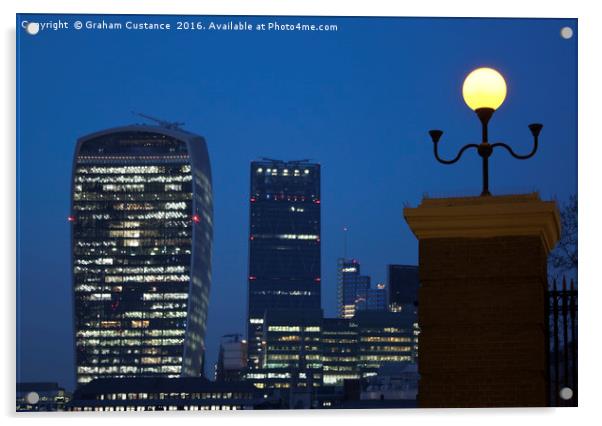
{"left": 66, "top": 377, "right": 281, "bottom": 411}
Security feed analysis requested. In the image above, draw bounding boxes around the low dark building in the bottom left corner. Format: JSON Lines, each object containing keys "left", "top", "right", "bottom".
{"left": 16, "top": 382, "right": 71, "bottom": 411}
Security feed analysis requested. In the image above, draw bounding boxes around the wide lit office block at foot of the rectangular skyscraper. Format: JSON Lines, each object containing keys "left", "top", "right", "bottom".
{"left": 245, "top": 310, "right": 418, "bottom": 389}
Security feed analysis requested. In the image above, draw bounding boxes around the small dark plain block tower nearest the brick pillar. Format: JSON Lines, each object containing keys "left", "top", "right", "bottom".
{"left": 387, "top": 265, "right": 419, "bottom": 312}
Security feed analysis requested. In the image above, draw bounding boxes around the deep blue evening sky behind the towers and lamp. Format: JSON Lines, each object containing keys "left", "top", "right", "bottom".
{"left": 17, "top": 15, "right": 577, "bottom": 388}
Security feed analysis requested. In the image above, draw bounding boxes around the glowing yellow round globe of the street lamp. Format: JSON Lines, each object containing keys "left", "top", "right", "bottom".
{"left": 462, "top": 68, "right": 507, "bottom": 111}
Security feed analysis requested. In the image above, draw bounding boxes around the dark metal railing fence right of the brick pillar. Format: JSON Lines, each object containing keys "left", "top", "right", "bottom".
{"left": 547, "top": 278, "right": 578, "bottom": 407}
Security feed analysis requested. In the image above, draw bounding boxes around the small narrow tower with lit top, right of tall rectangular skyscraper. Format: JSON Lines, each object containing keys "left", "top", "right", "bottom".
{"left": 337, "top": 258, "right": 370, "bottom": 318}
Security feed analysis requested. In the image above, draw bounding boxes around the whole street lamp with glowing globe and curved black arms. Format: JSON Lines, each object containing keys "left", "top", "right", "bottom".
{"left": 429, "top": 68, "right": 543, "bottom": 196}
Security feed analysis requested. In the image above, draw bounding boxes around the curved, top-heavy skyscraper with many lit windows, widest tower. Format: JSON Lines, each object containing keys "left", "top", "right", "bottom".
{"left": 69, "top": 124, "right": 213, "bottom": 384}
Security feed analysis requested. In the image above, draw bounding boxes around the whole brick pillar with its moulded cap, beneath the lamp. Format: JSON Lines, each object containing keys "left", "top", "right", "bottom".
{"left": 404, "top": 194, "right": 560, "bottom": 407}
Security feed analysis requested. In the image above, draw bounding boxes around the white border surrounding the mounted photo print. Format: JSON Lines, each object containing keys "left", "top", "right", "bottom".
{"left": 0, "top": 0, "right": 602, "bottom": 426}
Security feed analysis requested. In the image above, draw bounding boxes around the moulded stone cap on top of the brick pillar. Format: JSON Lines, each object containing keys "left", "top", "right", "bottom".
{"left": 403, "top": 193, "right": 561, "bottom": 252}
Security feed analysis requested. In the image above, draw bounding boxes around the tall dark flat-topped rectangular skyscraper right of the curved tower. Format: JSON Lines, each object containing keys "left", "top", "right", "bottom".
{"left": 247, "top": 159, "right": 321, "bottom": 369}
